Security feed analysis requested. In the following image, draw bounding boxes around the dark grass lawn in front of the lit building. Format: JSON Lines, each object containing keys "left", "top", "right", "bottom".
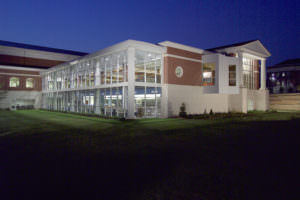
{"left": 0, "top": 111, "right": 300, "bottom": 200}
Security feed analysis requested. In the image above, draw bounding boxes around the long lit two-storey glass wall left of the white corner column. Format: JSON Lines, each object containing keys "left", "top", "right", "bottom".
{"left": 42, "top": 50, "right": 128, "bottom": 117}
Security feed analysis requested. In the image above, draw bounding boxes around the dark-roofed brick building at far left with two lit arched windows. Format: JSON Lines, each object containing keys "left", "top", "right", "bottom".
{"left": 0, "top": 40, "right": 86, "bottom": 109}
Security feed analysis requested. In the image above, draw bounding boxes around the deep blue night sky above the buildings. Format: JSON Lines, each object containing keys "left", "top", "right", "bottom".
{"left": 0, "top": 0, "right": 300, "bottom": 65}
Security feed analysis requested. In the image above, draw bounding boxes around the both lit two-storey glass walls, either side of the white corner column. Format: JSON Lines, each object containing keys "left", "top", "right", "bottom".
{"left": 42, "top": 49, "right": 162, "bottom": 118}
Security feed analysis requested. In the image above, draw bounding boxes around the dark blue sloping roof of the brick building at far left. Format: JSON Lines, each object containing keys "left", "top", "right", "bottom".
{"left": 0, "top": 40, "right": 87, "bottom": 56}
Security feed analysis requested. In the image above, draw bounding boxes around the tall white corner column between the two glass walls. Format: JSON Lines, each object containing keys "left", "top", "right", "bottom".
{"left": 127, "top": 47, "right": 135, "bottom": 119}
